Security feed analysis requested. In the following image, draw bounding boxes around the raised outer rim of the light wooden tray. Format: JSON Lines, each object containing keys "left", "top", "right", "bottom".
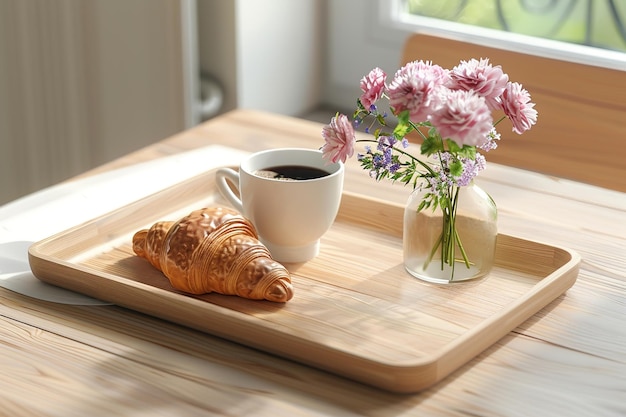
{"left": 28, "top": 169, "right": 581, "bottom": 393}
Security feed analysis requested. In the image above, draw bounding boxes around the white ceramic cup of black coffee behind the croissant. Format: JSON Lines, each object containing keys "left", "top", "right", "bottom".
{"left": 216, "top": 148, "right": 344, "bottom": 262}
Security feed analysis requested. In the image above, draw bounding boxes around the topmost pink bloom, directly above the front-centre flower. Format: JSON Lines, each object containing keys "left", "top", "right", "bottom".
{"left": 448, "top": 58, "right": 509, "bottom": 110}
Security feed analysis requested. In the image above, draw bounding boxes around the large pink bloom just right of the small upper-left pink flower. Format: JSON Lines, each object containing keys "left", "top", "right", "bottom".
{"left": 387, "top": 61, "right": 448, "bottom": 121}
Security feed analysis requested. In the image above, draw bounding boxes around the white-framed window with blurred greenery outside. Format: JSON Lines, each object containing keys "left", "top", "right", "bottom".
{"left": 379, "top": 0, "right": 626, "bottom": 70}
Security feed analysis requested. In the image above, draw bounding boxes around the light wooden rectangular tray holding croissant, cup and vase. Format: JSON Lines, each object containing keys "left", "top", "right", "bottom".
{"left": 29, "top": 167, "right": 580, "bottom": 393}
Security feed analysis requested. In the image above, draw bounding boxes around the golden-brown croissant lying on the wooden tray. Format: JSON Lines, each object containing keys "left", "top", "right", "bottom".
{"left": 133, "top": 207, "right": 293, "bottom": 302}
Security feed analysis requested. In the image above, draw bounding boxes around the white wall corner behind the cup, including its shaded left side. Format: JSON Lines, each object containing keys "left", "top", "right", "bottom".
{"left": 198, "top": 0, "right": 325, "bottom": 115}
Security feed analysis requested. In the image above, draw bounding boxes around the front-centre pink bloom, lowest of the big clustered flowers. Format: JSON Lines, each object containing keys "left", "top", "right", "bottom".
{"left": 431, "top": 90, "right": 493, "bottom": 146}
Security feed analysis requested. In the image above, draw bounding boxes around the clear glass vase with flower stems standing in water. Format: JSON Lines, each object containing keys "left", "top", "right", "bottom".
{"left": 403, "top": 183, "right": 498, "bottom": 283}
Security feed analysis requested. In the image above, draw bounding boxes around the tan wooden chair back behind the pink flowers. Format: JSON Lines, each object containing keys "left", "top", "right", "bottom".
{"left": 402, "top": 34, "right": 626, "bottom": 192}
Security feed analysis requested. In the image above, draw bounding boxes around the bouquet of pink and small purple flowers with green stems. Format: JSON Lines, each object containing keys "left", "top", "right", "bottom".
{"left": 322, "top": 59, "right": 537, "bottom": 281}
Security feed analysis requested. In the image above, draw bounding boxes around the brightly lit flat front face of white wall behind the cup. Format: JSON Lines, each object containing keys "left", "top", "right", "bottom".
{"left": 236, "top": 0, "right": 322, "bottom": 115}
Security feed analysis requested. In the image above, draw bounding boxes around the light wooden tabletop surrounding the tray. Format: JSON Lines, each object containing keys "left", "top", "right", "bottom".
{"left": 0, "top": 110, "right": 626, "bottom": 416}
